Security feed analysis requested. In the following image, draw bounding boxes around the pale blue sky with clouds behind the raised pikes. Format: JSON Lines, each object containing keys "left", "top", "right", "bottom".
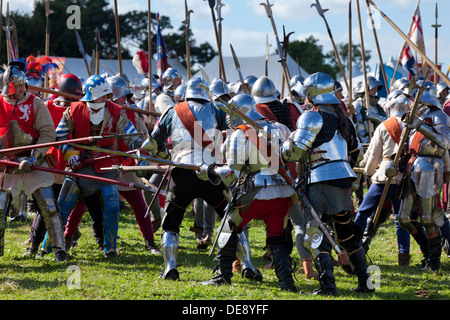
{"left": 7, "top": 0, "right": 450, "bottom": 73}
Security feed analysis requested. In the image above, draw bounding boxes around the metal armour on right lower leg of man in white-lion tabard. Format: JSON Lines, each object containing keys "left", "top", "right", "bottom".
{"left": 33, "top": 187, "right": 65, "bottom": 253}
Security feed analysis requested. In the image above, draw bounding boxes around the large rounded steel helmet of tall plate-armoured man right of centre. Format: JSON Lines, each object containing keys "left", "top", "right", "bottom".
{"left": 303, "top": 72, "right": 340, "bottom": 104}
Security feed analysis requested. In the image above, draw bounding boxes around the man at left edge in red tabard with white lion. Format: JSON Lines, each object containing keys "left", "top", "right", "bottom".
{"left": 0, "top": 61, "right": 66, "bottom": 261}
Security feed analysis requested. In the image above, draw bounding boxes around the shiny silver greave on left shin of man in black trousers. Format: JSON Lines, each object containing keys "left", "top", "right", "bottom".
{"left": 161, "top": 231, "right": 179, "bottom": 280}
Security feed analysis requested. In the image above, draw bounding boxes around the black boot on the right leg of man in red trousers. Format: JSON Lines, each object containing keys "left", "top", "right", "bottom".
{"left": 271, "top": 244, "right": 297, "bottom": 292}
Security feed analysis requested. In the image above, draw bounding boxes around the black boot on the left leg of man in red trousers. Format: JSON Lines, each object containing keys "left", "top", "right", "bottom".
{"left": 201, "top": 233, "right": 238, "bottom": 285}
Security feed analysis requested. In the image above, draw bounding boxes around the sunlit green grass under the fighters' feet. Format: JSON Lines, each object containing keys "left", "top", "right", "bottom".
{"left": 0, "top": 207, "right": 450, "bottom": 301}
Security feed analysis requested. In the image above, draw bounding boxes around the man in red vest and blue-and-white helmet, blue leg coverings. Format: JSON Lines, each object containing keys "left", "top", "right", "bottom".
{"left": 56, "top": 75, "right": 150, "bottom": 257}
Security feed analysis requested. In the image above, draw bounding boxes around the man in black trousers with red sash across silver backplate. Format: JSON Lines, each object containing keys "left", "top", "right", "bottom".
{"left": 151, "top": 77, "right": 259, "bottom": 280}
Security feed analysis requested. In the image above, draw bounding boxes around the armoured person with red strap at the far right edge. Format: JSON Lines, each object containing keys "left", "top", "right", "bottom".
{"left": 398, "top": 91, "right": 450, "bottom": 271}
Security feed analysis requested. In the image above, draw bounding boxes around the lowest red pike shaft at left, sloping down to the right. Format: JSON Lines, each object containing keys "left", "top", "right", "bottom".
{"left": 0, "top": 160, "right": 154, "bottom": 192}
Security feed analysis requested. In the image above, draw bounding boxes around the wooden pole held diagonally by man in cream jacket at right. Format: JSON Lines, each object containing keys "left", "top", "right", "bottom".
{"left": 373, "top": 69, "right": 430, "bottom": 225}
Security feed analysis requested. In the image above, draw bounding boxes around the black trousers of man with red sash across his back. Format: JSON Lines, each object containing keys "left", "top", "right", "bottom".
{"left": 162, "top": 168, "right": 228, "bottom": 233}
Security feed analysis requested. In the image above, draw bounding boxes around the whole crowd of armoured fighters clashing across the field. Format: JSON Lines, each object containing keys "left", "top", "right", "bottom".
{"left": 0, "top": 54, "right": 450, "bottom": 295}
